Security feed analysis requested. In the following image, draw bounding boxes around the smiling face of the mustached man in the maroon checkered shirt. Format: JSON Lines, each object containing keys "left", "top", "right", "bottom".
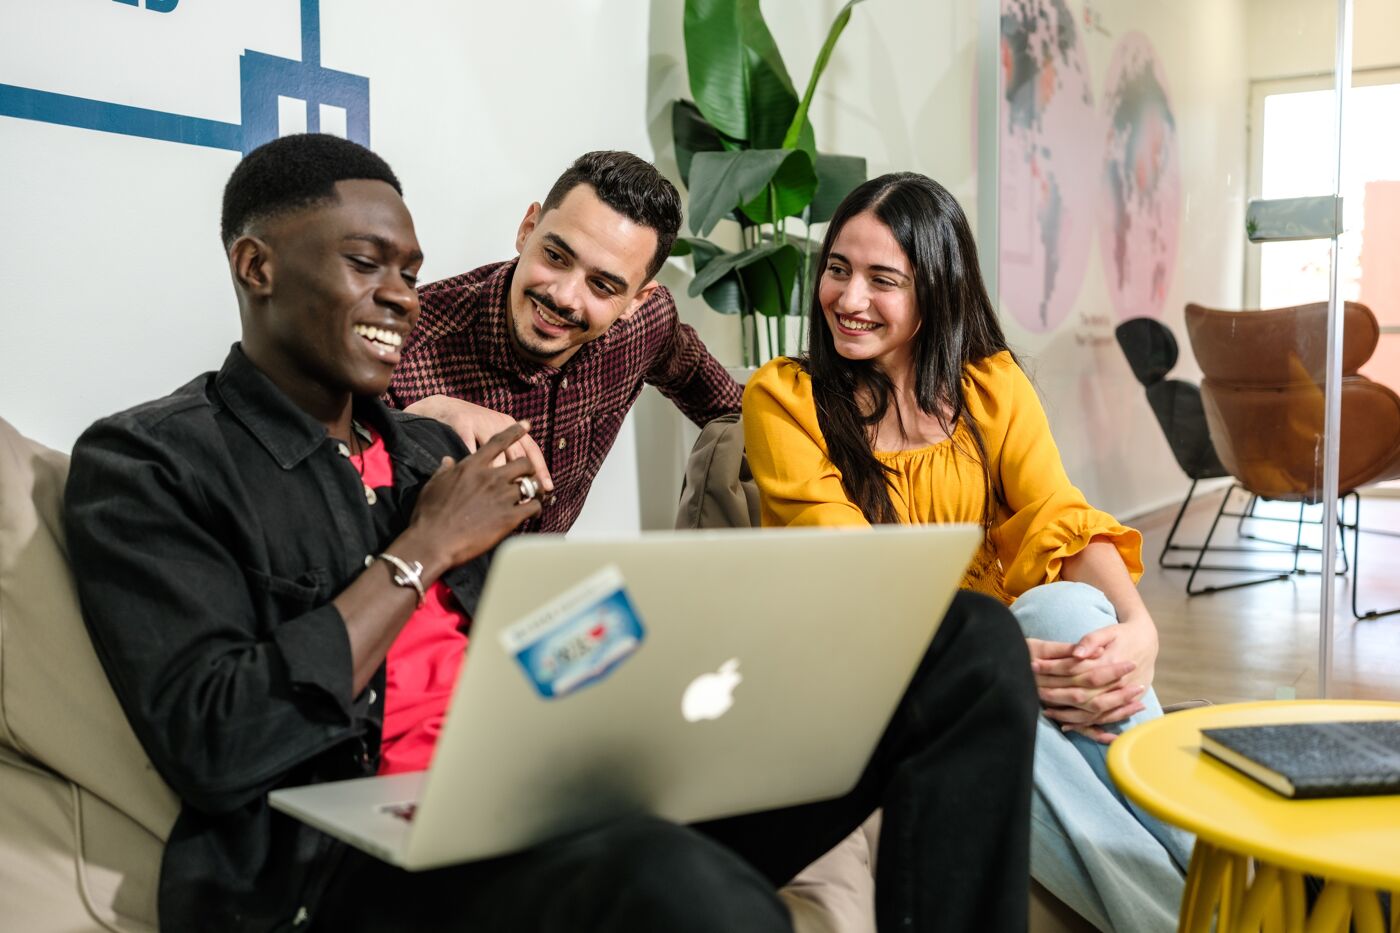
{"left": 507, "top": 184, "right": 657, "bottom": 367}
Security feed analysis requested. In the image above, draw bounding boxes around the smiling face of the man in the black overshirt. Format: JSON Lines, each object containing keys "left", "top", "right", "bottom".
{"left": 230, "top": 179, "right": 423, "bottom": 424}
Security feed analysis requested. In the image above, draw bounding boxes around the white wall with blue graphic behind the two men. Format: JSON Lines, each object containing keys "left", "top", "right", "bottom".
{"left": 0, "top": 0, "right": 650, "bottom": 528}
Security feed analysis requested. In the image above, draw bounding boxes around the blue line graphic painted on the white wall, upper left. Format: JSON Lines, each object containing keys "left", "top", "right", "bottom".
{"left": 0, "top": 0, "right": 370, "bottom": 154}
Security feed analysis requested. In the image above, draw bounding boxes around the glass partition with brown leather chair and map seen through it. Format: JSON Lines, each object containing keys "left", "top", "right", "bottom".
{"left": 979, "top": 0, "right": 1400, "bottom": 702}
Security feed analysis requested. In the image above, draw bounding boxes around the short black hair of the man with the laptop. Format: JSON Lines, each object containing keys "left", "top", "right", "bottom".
{"left": 218, "top": 133, "right": 403, "bottom": 249}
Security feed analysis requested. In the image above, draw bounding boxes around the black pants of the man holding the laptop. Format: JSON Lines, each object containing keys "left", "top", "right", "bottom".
{"left": 315, "top": 594, "right": 1039, "bottom": 933}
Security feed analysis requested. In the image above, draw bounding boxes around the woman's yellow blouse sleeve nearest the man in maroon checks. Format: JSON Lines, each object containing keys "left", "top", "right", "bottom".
{"left": 743, "top": 357, "right": 869, "bottom": 527}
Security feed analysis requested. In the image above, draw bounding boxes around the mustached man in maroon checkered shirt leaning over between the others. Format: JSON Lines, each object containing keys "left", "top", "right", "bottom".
{"left": 388, "top": 151, "right": 741, "bottom": 531}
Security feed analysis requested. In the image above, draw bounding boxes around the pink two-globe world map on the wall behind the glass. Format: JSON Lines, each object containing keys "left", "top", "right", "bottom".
{"left": 1000, "top": 0, "right": 1182, "bottom": 332}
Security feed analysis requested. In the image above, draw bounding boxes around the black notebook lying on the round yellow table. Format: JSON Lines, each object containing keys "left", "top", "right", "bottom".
{"left": 1201, "top": 720, "right": 1400, "bottom": 799}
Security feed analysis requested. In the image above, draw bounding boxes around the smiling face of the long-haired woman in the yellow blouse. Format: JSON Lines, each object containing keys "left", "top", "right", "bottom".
{"left": 818, "top": 212, "right": 923, "bottom": 382}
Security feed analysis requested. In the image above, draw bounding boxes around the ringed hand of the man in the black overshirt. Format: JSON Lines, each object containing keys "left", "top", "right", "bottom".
{"left": 396, "top": 423, "right": 539, "bottom": 577}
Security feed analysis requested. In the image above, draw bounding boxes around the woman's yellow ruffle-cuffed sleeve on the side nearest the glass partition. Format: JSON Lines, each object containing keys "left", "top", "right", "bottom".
{"left": 963, "top": 353, "right": 1142, "bottom": 597}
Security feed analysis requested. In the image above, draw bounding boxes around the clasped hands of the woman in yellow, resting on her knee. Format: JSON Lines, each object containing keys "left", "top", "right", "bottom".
{"left": 1026, "top": 621, "right": 1156, "bottom": 744}
